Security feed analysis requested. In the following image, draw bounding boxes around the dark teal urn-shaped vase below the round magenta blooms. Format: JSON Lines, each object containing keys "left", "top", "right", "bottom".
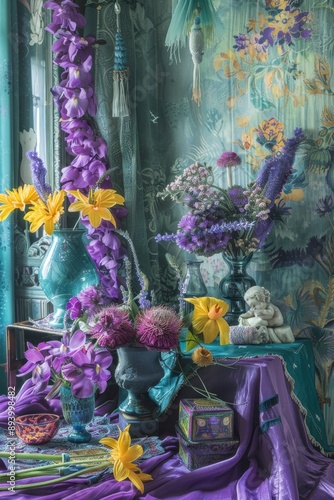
{"left": 115, "top": 347, "right": 164, "bottom": 418}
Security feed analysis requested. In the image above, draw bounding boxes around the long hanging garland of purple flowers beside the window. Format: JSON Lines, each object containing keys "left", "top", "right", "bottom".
{"left": 44, "top": 0, "right": 126, "bottom": 299}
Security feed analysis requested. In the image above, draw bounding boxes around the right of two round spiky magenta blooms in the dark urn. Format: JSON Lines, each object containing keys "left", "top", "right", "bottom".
{"left": 136, "top": 306, "right": 182, "bottom": 351}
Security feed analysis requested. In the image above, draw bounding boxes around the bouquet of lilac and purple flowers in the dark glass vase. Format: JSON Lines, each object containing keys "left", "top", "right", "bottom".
{"left": 156, "top": 129, "right": 305, "bottom": 258}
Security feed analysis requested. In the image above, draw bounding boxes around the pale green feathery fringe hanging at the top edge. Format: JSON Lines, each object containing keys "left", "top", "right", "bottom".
{"left": 165, "top": 0, "right": 222, "bottom": 60}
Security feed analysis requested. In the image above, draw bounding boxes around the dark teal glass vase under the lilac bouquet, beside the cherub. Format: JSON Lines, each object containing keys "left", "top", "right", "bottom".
{"left": 219, "top": 253, "right": 256, "bottom": 326}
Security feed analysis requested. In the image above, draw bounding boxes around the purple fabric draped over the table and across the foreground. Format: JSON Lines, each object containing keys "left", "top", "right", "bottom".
{"left": 0, "top": 356, "right": 334, "bottom": 500}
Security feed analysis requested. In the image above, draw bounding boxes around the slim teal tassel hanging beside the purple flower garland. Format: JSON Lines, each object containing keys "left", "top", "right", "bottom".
{"left": 112, "top": 0, "right": 130, "bottom": 118}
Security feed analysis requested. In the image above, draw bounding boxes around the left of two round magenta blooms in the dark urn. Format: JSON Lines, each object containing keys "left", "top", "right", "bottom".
{"left": 89, "top": 306, "right": 136, "bottom": 349}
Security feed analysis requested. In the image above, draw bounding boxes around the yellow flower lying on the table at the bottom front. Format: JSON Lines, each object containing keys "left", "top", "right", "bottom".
{"left": 100, "top": 425, "right": 153, "bottom": 493}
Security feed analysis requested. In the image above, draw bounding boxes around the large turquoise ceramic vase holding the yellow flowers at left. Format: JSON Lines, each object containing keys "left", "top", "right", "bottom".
{"left": 39, "top": 229, "right": 99, "bottom": 328}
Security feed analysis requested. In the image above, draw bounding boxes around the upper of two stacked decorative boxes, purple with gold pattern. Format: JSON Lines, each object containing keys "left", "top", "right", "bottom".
{"left": 179, "top": 398, "right": 233, "bottom": 442}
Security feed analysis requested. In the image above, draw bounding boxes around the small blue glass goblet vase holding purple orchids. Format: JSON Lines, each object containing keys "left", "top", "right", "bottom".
{"left": 60, "top": 385, "right": 95, "bottom": 443}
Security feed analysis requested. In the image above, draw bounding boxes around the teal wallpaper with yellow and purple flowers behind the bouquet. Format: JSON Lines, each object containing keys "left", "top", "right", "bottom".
{"left": 90, "top": 0, "right": 334, "bottom": 440}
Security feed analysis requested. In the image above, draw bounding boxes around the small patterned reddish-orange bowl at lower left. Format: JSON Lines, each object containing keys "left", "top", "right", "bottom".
{"left": 15, "top": 413, "right": 60, "bottom": 444}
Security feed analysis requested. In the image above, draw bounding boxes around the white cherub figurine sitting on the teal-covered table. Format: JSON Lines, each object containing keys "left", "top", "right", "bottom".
{"left": 239, "top": 286, "right": 295, "bottom": 344}
